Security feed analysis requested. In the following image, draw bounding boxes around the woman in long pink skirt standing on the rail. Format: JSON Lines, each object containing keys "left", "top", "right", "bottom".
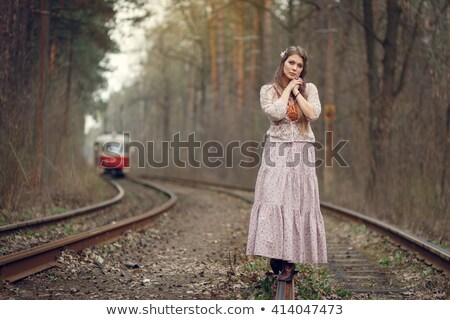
{"left": 247, "top": 46, "right": 327, "bottom": 281}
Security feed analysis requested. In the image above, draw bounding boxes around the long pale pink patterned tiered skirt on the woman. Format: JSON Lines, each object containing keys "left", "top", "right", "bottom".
{"left": 247, "top": 141, "right": 327, "bottom": 263}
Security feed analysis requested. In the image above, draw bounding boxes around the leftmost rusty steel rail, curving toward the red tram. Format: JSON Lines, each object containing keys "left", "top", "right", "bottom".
{"left": 0, "top": 180, "right": 125, "bottom": 235}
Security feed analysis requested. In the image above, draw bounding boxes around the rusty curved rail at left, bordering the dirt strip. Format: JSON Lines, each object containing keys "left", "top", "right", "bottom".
{"left": 0, "top": 177, "right": 177, "bottom": 282}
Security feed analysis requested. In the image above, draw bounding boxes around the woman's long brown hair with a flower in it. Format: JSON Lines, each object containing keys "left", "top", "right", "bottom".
{"left": 274, "top": 46, "right": 308, "bottom": 133}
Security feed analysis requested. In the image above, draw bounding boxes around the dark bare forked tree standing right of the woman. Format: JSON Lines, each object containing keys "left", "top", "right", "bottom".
{"left": 362, "top": 0, "right": 423, "bottom": 191}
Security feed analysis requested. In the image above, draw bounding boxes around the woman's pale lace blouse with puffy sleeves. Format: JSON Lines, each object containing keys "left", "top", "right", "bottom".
{"left": 260, "top": 83, "right": 321, "bottom": 142}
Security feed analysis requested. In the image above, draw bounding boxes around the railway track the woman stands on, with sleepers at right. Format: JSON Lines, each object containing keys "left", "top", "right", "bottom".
{"left": 143, "top": 176, "right": 450, "bottom": 300}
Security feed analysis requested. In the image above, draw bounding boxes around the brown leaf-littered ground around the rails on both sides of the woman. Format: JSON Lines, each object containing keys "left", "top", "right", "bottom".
{"left": 0, "top": 182, "right": 449, "bottom": 300}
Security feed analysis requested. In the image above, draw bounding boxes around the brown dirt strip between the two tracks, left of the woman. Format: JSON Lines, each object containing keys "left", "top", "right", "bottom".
{"left": 0, "top": 183, "right": 250, "bottom": 299}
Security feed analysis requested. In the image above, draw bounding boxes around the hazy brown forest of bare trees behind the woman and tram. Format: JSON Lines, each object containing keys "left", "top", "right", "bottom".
{"left": 0, "top": 0, "right": 450, "bottom": 247}
